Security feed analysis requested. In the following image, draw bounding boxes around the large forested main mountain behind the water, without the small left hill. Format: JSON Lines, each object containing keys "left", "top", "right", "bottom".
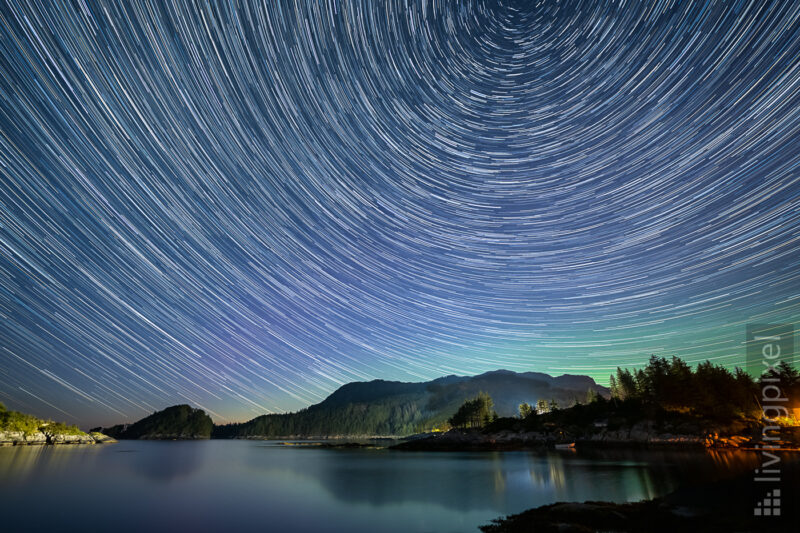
{"left": 213, "top": 370, "right": 608, "bottom": 438}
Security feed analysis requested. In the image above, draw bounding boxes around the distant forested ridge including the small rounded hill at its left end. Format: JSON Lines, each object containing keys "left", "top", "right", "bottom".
{"left": 98, "top": 369, "right": 609, "bottom": 439}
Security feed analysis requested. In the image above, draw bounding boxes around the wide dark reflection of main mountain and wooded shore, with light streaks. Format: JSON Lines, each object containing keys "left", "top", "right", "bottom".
{"left": 241, "top": 449, "right": 757, "bottom": 511}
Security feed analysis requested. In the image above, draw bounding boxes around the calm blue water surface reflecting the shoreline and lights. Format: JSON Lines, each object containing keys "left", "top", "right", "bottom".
{"left": 0, "top": 441, "right": 757, "bottom": 533}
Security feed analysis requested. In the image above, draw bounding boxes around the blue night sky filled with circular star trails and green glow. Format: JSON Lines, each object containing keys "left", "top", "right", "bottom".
{"left": 0, "top": 0, "right": 800, "bottom": 425}
